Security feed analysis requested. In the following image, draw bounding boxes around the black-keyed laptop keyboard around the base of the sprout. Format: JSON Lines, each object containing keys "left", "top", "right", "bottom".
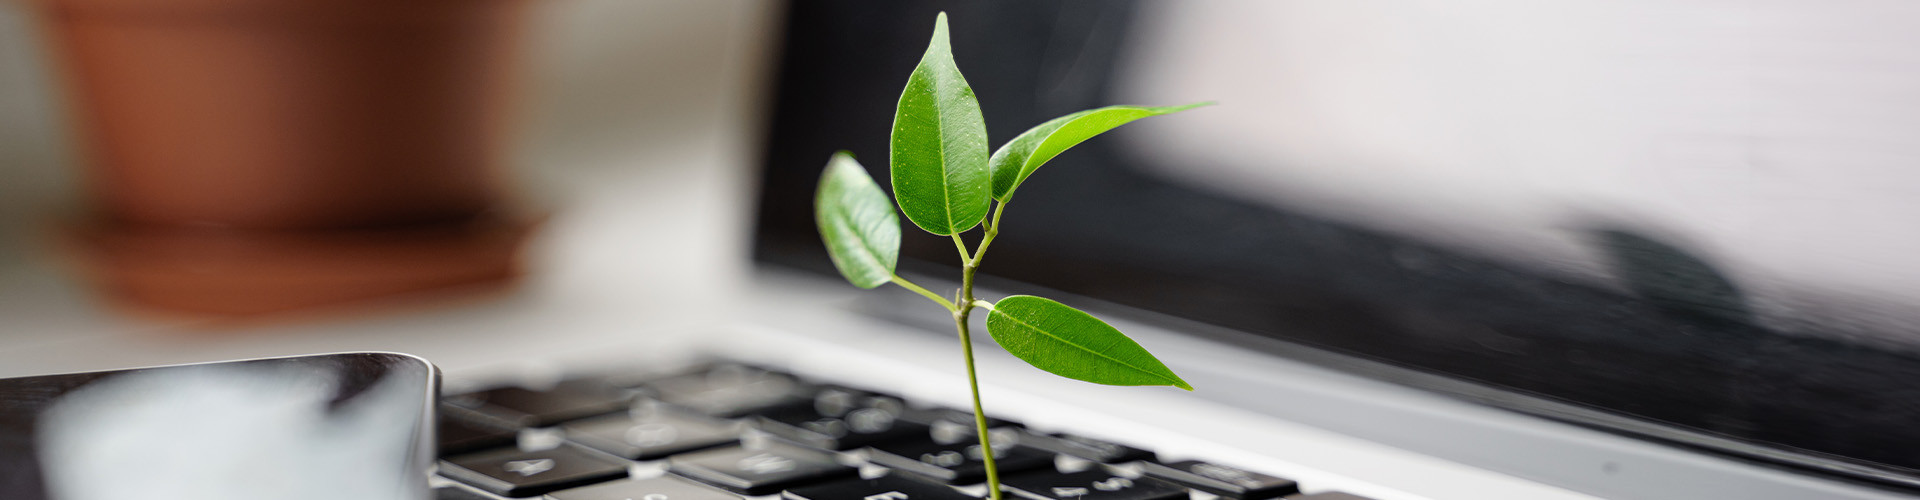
{"left": 436, "top": 363, "right": 1367, "bottom": 500}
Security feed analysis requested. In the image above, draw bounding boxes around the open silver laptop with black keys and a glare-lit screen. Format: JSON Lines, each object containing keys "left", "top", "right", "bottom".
{"left": 3, "top": 2, "right": 1920, "bottom": 500}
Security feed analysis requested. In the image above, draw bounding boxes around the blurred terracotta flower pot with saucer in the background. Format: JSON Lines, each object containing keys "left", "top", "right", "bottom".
{"left": 35, "top": 0, "right": 530, "bottom": 313}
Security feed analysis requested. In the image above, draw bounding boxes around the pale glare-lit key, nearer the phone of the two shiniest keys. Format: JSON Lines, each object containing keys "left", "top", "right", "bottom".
{"left": 561, "top": 408, "right": 741, "bottom": 460}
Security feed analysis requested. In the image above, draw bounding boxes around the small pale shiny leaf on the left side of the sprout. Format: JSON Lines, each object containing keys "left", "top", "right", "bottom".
{"left": 814, "top": 152, "right": 900, "bottom": 288}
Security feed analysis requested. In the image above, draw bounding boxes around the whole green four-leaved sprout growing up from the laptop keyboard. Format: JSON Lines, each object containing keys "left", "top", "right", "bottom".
{"left": 814, "top": 13, "right": 1206, "bottom": 500}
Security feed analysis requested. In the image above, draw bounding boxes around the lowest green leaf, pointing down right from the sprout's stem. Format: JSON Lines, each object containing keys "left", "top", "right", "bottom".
{"left": 987, "top": 294, "right": 1194, "bottom": 390}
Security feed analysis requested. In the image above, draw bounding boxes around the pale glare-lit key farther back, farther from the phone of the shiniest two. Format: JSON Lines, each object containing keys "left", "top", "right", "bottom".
{"left": 647, "top": 363, "right": 812, "bottom": 417}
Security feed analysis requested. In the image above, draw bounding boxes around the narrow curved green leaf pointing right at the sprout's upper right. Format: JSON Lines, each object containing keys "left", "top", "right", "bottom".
{"left": 987, "top": 102, "right": 1212, "bottom": 204}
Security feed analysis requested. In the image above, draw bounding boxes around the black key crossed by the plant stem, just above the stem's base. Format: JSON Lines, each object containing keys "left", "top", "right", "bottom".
{"left": 868, "top": 433, "right": 1054, "bottom": 485}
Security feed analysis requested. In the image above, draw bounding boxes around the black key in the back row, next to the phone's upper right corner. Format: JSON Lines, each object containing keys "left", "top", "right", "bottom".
{"left": 444, "top": 379, "right": 636, "bottom": 427}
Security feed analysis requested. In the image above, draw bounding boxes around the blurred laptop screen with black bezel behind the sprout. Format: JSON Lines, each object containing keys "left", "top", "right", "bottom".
{"left": 756, "top": 0, "right": 1920, "bottom": 485}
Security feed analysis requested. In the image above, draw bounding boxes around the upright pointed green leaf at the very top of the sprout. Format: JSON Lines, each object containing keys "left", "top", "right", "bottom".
{"left": 889, "top": 13, "right": 991, "bottom": 235}
